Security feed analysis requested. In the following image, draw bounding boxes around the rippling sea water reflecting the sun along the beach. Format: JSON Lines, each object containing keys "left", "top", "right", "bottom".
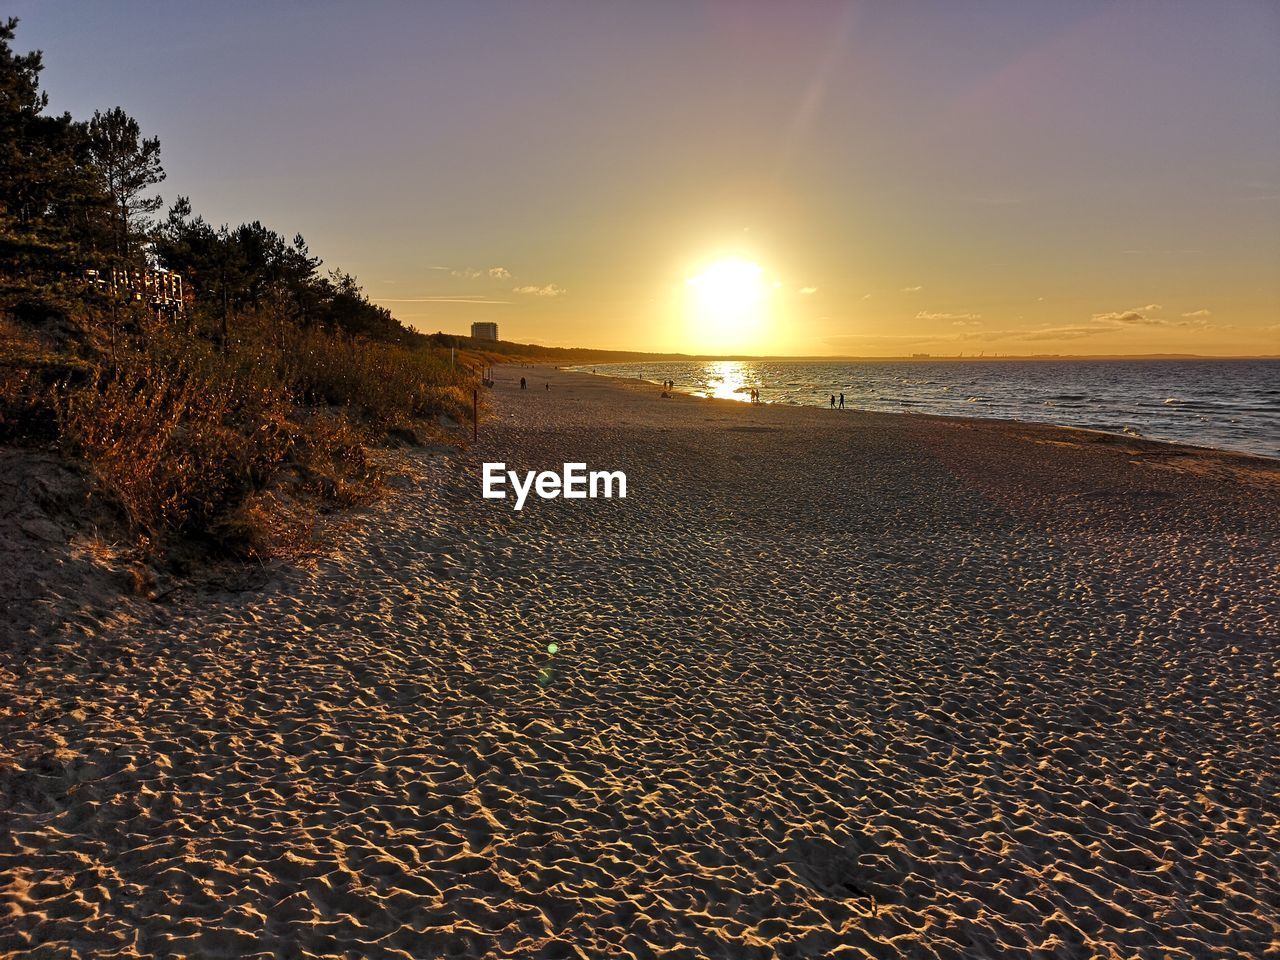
{"left": 575, "top": 360, "right": 1280, "bottom": 457}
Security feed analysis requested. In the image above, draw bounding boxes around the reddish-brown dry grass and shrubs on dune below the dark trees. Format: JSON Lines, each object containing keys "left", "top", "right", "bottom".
{"left": 0, "top": 312, "right": 472, "bottom": 558}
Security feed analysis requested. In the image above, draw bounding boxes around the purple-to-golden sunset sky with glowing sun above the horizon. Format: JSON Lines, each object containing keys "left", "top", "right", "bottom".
{"left": 6, "top": 0, "right": 1280, "bottom": 356}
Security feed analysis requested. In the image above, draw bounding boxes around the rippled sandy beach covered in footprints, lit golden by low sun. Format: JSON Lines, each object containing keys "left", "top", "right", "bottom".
{"left": 0, "top": 369, "right": 1280, "bottom": 957}
